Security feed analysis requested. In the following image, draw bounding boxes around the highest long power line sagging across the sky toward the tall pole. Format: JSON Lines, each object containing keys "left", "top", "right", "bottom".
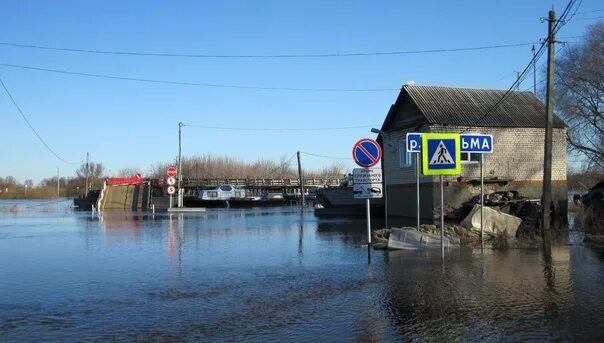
{"left": 0, "top": 42, "right": 535, "bottom": 59}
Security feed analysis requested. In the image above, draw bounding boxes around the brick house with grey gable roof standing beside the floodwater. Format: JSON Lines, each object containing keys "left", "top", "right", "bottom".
{"left": 378, "top": 85, "right": 567, "bottom": 223}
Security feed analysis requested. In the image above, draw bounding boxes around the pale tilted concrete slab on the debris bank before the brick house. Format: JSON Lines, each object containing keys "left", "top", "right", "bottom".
{"left": 461, "top": 204, "right": 522, "bottom": 237}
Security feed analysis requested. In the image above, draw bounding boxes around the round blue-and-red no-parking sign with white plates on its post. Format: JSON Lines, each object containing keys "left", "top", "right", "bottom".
{"left": 352, "top": 138, "right": 382, "bottom": 259}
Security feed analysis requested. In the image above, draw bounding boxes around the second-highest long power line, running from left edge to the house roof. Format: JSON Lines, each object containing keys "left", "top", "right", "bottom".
{"left": 0, "top": 63, "right": 400, "bottom": 92}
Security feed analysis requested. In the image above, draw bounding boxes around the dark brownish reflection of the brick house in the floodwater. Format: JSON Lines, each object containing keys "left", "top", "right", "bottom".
{"left": 385, "top": 246, "right": 573, "bottom": 341}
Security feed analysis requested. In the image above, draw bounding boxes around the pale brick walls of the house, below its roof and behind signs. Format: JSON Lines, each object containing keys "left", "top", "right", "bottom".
{"left": 382, "top": 126, "right": 567, "bottom": 220}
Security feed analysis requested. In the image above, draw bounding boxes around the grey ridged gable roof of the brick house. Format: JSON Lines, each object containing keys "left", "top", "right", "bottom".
{"left": 391, "top": 85, "right": 565, "bottom": 127}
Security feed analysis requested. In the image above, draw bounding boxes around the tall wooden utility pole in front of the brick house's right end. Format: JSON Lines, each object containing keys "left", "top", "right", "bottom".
{"left": 541, "top": 11, "right": 556, "bottom": 242}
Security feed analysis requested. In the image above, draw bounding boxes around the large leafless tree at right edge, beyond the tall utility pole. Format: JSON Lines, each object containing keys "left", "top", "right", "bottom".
{"left": 555, "top": 21, "right": 604, "bottom": 173}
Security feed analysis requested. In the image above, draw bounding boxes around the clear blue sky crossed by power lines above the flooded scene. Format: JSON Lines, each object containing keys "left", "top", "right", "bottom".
{"left": 0, "top": 0, "right": 604, "bottom": 182}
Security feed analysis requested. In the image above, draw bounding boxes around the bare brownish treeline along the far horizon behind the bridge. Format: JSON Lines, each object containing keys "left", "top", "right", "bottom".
{"left": 0, "top": 154, "right": 345, "bottom": 199}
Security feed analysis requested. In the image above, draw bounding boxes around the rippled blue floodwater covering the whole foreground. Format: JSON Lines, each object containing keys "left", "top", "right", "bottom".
{"left": 0, "top": 202, "right": 604, "bottom": 342}
